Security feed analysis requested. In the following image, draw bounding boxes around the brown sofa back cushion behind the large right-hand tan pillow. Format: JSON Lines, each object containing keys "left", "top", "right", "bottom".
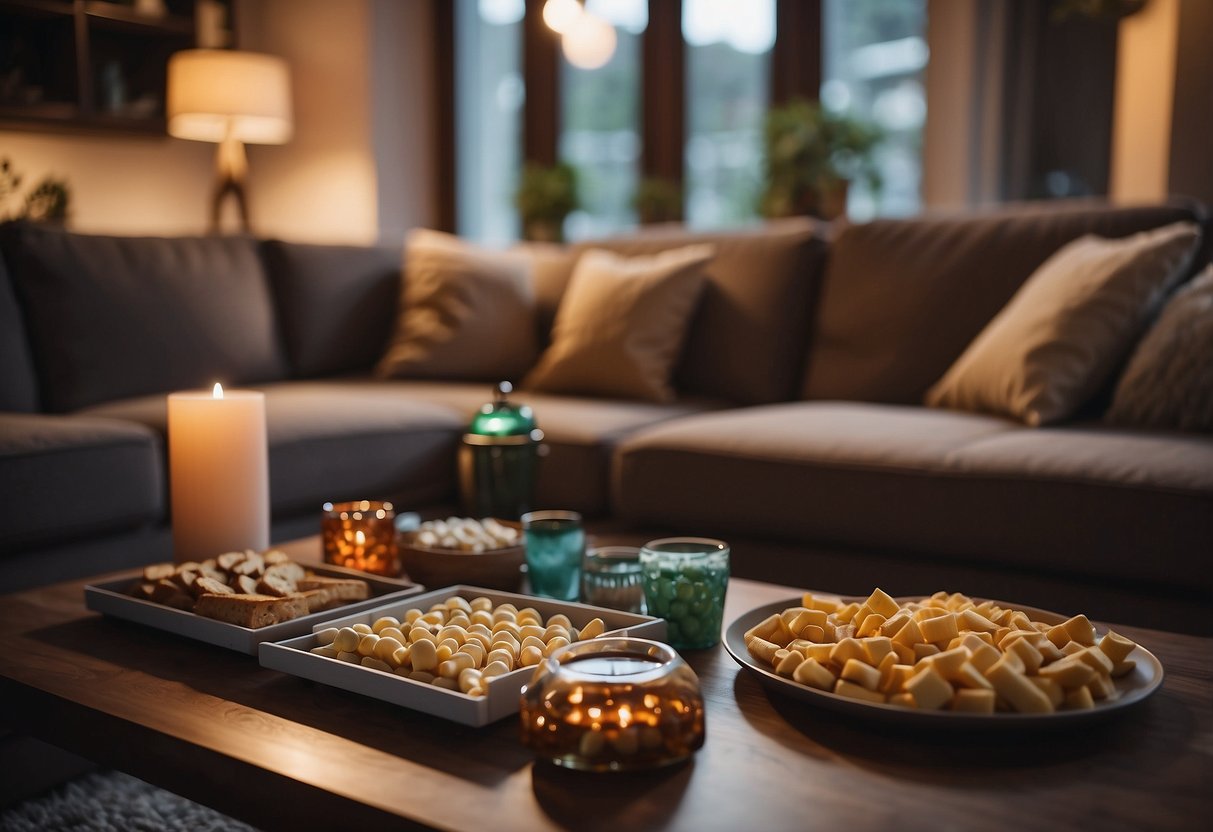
{"left": 802, "top": 201, "right": 1202, "bottom": 404}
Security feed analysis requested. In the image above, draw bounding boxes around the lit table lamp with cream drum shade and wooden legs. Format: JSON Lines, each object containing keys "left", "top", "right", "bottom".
{"left": 167, "top": 49, "right": 291, "bottom": 233}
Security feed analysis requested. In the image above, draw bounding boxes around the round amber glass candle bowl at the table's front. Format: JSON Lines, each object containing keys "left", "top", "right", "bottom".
{"left": 522, "top": 637, "right": 704, "bottom": 771}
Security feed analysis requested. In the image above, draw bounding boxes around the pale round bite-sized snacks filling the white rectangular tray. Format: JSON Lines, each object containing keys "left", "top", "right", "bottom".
{"left": 312, "top": 595, "right": 605, "bottom": 696}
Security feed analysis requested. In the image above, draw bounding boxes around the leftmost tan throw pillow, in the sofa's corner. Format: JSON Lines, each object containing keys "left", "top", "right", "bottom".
{"left": 376, "top": 229, "right": 539, "bottom": 381}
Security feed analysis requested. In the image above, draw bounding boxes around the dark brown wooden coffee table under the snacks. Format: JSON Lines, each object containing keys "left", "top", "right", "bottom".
{"left": 0, "top": 538, "right": 1213, "bottom": 832}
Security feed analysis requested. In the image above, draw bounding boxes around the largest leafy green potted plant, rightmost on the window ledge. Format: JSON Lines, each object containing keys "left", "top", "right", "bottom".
{"left": 761, "top": 99, "right": 882, "bottom": 220}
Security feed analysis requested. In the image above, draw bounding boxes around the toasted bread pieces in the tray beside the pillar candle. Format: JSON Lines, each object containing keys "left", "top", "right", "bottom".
{"left": 130, "top": 549, "right": 370, "bottom": 629}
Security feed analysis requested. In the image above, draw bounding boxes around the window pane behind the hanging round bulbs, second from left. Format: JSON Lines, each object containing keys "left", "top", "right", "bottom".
{"left": 559, "top": 0, "right": 649, "bottom": 239}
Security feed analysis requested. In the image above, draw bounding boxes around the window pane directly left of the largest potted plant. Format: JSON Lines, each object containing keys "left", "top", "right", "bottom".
{"left": 682, "top": 0, "right": 775, "bottom": 228}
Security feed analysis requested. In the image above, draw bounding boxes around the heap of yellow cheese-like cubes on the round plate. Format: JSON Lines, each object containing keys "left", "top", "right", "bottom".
{"left": 745, "top": 589, "right": 1137, "bottom": 713}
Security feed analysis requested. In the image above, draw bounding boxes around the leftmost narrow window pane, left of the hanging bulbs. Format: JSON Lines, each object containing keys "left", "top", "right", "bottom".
{"left": 455, "top": 0, "right": 525, "bottom": 243}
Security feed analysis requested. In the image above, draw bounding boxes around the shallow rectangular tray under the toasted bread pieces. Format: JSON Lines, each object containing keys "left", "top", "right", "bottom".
{"left": 84, "top": 565, "right": 425, "bottom": 656}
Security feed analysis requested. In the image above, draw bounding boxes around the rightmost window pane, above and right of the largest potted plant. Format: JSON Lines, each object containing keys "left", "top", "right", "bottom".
{"left": 821, "top": 0, "right": 927, "bottom": 220}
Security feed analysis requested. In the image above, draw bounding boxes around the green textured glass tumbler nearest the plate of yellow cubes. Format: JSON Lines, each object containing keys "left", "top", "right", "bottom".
{"left": 640, "top": 537, "right": 729, "bottom": 650}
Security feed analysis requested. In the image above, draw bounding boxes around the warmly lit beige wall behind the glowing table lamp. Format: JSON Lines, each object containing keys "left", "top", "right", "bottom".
{"left": 0, "top": 0, "right": 433, "bottom": 243}
